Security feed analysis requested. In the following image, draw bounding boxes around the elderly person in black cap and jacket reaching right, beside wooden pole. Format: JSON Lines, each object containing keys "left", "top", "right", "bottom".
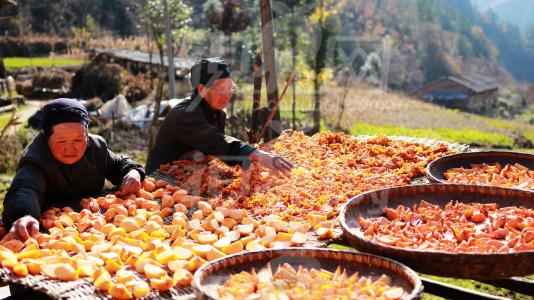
{"left": 146, "top": 57, "right": 292, "bottom": 173}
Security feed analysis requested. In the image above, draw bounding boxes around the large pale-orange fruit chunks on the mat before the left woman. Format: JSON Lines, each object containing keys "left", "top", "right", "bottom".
{"left": 0, "top": 178, "right": 334, "bottom": 299}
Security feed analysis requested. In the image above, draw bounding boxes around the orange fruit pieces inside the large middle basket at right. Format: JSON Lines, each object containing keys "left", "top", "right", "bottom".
{"left": 358, "top": 201, "right": 534, "bottom": 253}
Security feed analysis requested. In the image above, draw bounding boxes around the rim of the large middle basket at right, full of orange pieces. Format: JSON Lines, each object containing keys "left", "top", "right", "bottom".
{"left": 339, "top": 183, "right": 534, "bottom": 257}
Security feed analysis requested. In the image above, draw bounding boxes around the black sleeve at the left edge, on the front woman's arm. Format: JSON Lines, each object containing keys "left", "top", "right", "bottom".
{"left": 2, "top": 162, "right": 47, "bottom": 230}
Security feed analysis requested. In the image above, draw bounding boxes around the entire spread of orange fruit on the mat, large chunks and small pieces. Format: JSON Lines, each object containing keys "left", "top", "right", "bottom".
{"left": 0, "top": 132, "right": 451, "bottom": 299}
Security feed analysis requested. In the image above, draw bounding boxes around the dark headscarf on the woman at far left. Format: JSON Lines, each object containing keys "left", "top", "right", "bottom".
{"left": 41, "top": 98, "right": 89, "bottom": 138}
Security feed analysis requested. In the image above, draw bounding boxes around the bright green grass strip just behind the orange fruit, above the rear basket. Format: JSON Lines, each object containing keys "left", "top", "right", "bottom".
{"left": 351, "top": 123, "right": 514, "bottom": 148}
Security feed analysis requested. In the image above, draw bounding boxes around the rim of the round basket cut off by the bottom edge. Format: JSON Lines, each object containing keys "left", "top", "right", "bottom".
{"left": 192, "top": 247, "right": 424, "bottom": 299}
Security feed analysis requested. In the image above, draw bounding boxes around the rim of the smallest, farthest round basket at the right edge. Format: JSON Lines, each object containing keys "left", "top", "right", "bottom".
{"left": 425, "top": 150, "right": 534, "bottom": 184}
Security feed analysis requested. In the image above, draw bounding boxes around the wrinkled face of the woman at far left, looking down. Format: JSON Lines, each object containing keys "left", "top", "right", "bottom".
{"left": 48, "top": 122, "right": 87, "bottom": 165}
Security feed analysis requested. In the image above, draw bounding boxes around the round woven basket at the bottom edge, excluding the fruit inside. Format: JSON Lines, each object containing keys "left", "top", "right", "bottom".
{"left": 193, "top": 248, "right": 423, "bottom": 299}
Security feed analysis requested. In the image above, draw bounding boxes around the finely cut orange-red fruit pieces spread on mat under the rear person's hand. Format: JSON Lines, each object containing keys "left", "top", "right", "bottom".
{"left": 160, "top": 132, "right": 452, "bottom": 220}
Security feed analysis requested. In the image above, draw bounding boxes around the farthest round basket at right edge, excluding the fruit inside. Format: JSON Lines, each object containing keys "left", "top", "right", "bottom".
{"left": 426, "top": 151, "right": 534, "bottom": 183}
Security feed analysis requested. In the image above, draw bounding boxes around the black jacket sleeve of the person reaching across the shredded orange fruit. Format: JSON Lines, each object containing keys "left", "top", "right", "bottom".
{"left": 175, "top": 111, "right": 255, "bottom": 156}
